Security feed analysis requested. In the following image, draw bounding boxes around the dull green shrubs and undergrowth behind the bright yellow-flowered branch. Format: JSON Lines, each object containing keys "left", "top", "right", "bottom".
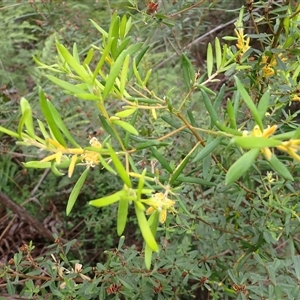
{"left": 0, "top": 0, "right": 300, "bottom": 299}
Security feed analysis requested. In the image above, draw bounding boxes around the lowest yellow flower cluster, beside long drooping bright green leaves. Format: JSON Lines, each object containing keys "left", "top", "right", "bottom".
{"left": 145, "top": 193, "right": 175, "bottom": 224}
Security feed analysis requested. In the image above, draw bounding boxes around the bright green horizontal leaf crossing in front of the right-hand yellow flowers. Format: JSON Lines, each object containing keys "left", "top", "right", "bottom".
{"left": 232, "top": 136, "right": 282, "bottom": 149}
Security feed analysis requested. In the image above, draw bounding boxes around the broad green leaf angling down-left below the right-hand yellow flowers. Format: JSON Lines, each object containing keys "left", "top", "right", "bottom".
{"left": 225, "top": 149, "right": 259, "bottom": 184}
